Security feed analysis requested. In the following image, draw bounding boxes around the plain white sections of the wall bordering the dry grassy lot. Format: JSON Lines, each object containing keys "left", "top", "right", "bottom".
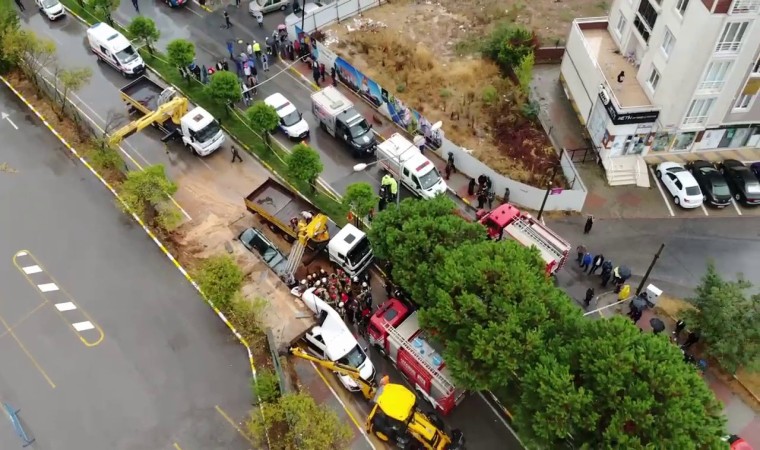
{"left": 317, "top": 42, "right": 586, "bottom": 211}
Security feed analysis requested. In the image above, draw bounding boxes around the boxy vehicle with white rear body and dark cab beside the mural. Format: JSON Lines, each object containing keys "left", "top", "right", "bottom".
{"left": 311, "top": 86, "right": 377, "bottom": 157}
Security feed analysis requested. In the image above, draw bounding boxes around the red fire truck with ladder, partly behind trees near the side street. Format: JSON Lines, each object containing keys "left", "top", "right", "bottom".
{"left": 477, "top": 203, "right": 570, "bottom": 275}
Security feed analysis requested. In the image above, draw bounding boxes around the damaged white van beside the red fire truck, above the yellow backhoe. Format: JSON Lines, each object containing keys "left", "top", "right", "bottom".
{"left": 301, "top": 288, "right": 375, "bottom": 392}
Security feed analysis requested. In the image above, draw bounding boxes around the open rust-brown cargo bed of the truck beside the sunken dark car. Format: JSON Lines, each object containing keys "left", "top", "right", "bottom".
{"left": 245, "top": 178, "right": 339, "bottom": 243}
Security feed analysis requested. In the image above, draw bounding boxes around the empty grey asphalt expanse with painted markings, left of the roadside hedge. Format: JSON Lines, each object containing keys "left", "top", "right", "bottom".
{"left": 0, "top": 83, "right": 251, "bottom": 450}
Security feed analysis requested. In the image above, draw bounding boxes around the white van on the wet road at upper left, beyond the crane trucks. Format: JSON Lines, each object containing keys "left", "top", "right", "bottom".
{"left": 87, "top": 22, "right": 145, "bottom": 77}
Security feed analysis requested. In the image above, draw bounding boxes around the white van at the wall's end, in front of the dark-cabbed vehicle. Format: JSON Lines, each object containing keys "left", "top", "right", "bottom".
{"left": 377, "top": 133, "right": 447, "bottom": 199}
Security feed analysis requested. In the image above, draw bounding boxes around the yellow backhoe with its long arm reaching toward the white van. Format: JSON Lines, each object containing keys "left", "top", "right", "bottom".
{"left": 289, "top": 347, "right": 465, "bottom": 450}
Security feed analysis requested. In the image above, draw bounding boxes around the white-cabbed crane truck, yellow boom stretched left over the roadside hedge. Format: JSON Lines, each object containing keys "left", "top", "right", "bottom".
{"left": 114, "top": 75, "right": 225, "bottom": 156}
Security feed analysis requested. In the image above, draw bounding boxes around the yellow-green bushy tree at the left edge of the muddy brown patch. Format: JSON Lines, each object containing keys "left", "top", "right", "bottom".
{"left": 119, "top": 164, "right": 177, "bottom": 223}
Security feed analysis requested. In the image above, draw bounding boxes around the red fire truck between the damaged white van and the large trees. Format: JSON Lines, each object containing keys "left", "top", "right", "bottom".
{"left": 367, "top": 298, "right": 465, "bottom": 415}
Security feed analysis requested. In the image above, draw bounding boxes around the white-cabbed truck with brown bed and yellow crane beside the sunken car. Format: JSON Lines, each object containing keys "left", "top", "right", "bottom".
{"left": 245, "top": 178, "right": 374, "bottom": 283}
